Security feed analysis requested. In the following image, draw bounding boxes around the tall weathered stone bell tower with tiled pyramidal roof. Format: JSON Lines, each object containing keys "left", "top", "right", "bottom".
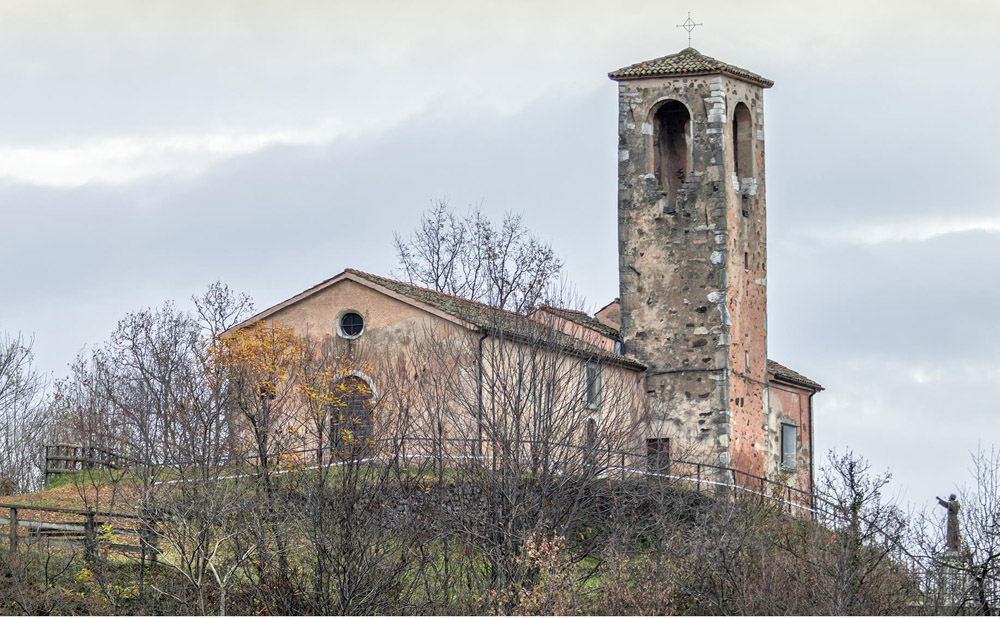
{"left": 609, "top": 47, "right": 773, "bottom": 474}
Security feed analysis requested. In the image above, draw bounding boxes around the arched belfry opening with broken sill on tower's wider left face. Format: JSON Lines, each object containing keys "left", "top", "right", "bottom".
{"left": 652, "top": 101, "right": 691, "bottom": 212}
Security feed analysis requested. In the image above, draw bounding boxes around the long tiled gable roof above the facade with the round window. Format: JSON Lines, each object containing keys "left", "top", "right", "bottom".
{"left": 227, "top": 269, "right": 646, "bottom": 370}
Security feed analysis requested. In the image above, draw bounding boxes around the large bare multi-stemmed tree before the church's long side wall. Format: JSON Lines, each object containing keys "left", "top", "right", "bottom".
{"left": 400, "top": 294, "right": 641, "bottom": 612}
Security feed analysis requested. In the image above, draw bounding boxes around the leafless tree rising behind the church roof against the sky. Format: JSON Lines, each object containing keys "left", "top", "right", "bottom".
{"left": 394, "top": 200, "right": 563, "bottom": 313}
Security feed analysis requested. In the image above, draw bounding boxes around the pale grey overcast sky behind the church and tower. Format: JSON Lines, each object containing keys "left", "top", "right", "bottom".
{"left": 0, "top": 0, "right": 1000, "bottom": 504}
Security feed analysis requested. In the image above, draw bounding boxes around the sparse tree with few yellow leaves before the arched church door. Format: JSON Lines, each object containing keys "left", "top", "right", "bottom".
{"left": 287, "top": 348, "right": 431, "bottom": 615}
